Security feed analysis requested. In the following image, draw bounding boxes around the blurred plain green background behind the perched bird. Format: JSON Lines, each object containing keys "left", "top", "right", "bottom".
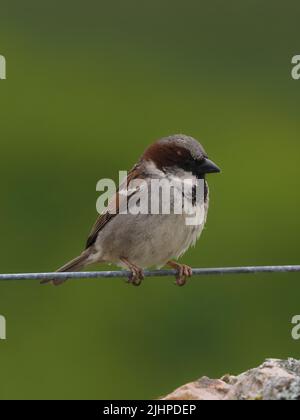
{"left": 0, "top": 0, "right": 300, "bottom": 399}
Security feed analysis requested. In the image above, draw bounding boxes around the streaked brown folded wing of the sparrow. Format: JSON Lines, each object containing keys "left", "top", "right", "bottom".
{"left": 86, "top": 165, "right": 144, "bottom": 249}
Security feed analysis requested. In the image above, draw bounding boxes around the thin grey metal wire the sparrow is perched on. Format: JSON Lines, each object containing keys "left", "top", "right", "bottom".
{"left": 0, "top": 265, "right": 300, "bottom": 281}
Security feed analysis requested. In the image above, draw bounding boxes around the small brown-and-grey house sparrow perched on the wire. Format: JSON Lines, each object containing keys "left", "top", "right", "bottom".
{"left": 44, "top": 135, "right": 220, "bottom": 286}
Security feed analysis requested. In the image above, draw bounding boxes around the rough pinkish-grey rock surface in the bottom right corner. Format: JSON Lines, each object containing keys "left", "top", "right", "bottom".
{"left": 162, "top": 359, "right": 300, "bottom": 400}
